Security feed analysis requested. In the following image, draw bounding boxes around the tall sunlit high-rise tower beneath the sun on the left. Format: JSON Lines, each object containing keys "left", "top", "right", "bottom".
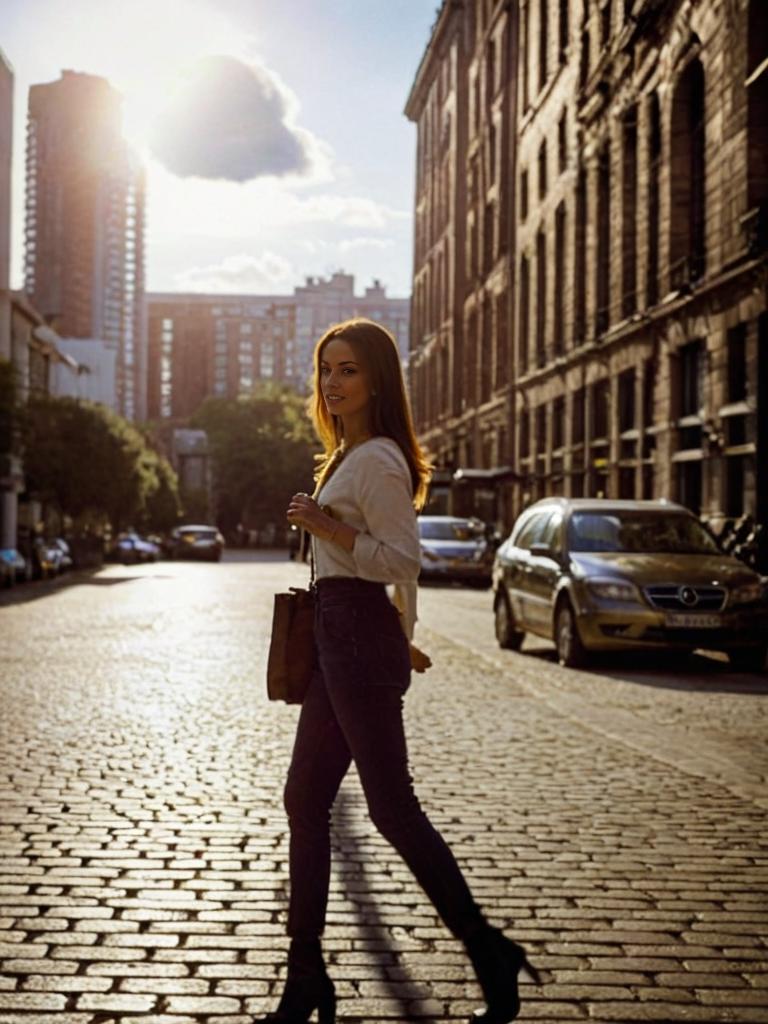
{"left": 25, "top": 71, "right": 146, "bottom": 419}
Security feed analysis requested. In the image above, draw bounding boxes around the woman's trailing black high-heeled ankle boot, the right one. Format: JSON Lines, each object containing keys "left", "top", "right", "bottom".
{"left": 464, "top": 924, "right": 541, "bottom": 1024}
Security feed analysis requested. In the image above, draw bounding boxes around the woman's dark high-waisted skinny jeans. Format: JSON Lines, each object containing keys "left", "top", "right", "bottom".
{"left": 285, "top": 578, "right": 479, "bottom": 938}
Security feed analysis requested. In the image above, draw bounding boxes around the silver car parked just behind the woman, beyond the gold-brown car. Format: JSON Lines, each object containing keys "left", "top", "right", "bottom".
{"left": 419, "top": 515, "right": 494, "bottom": 587}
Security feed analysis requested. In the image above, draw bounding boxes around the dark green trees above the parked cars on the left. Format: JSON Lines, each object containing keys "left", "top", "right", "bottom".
{"left": 25, "top": 396, "right": 178, "bottom": 530}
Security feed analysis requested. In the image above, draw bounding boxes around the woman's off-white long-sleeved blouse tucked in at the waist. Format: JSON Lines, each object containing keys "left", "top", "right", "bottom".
{"left": 312, "top": 437, "right": 421, "bottom": 639}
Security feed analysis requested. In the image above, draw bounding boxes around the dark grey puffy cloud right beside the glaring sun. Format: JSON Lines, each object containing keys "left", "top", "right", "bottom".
{"left": 150, "top": 56, "right": 322, "bottom": 182}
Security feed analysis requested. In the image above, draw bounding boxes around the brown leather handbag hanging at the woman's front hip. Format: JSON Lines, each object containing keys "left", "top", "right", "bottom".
{"left": 266, "top": 539, "right": 317, "bottom": 703}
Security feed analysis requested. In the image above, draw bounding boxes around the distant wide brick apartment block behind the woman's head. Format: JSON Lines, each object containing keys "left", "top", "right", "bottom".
{"left": 146, "top": 273, "right": 410, "bottom": 420}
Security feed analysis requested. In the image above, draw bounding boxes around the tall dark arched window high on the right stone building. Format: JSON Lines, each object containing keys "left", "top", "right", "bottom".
{"left": 670, "top": 59, "right": 707, "bottom": 288}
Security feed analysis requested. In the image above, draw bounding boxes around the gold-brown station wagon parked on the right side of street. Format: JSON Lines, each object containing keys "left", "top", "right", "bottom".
{"left": 494, "top": 498, "right": 768, "bottom": 671}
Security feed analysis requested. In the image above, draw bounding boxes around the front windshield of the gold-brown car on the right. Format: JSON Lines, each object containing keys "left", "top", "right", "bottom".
{"left": 568, "top": 512, "right": 719, "bottom": 555}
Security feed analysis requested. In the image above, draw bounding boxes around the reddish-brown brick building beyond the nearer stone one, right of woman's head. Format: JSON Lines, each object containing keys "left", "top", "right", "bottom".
{"left": 406, "top": 3, "right": 517, "bottom": 519}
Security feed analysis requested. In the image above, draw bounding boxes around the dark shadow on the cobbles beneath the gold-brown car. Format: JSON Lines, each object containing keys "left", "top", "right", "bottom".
{"left": 520, "top": 647, "right": 768, "bottom": 696}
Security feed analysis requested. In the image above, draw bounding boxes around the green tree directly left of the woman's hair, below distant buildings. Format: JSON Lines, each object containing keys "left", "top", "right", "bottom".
{"left": 189, "top": 386, "right": 317, "bottom": 530}
